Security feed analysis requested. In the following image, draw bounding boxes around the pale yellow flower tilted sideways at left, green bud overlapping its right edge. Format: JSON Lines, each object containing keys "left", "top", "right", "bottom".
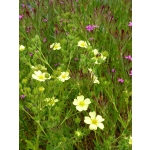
{"left": 32, "top": 70, "right": 51, "bottom": 81}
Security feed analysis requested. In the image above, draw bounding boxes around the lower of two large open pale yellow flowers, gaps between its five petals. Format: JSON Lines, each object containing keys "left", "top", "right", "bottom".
{"left": 84, "top": 111, "right": 104, "bottom": 130}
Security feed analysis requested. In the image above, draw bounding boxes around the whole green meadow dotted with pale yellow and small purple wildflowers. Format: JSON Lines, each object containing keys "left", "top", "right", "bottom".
{"left": 18, "top": 0, "right": 132, "bottom": 150}
